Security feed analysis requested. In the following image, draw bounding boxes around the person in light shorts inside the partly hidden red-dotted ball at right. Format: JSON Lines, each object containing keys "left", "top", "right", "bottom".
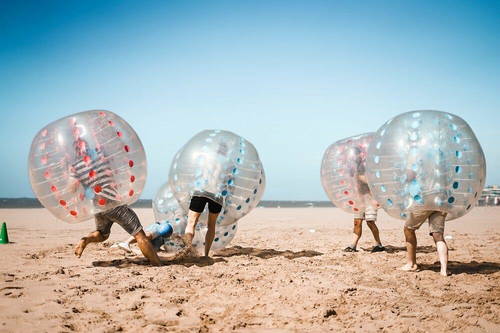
{"left": 344, "top": 147, "right": 385, "bottom": 252}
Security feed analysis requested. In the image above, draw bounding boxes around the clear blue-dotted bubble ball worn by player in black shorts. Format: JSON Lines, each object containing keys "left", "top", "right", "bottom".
{"left": 169, "top": 130, "right": 265, "bottom": 225}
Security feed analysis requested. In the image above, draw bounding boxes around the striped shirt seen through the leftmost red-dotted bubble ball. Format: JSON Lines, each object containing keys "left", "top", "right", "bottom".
{"left": 71, "top": 152, "right": 118, "bottom": 201}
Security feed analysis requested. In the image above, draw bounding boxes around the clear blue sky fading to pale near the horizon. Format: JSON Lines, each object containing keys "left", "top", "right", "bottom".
{"left": 0, "top": 0, "right": 500, "bottom": 200}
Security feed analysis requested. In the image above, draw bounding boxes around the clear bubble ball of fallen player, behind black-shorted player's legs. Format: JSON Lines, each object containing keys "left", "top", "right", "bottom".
{"left": 153, "top": 183, "right": 238, "bottom": 253}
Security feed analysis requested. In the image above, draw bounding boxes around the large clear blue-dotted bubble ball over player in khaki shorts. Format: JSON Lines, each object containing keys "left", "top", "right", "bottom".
{"left": 366, "top": 111, "right": 486, "bottom": 220}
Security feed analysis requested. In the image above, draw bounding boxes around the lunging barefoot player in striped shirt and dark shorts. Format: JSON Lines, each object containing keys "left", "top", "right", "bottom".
{"left": 69, "top": 132, "right": 161, "bottom": 265}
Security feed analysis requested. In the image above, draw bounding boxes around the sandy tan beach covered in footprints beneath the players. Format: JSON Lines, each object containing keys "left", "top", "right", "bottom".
{"left": 0, "top": 207, "right": 500, "bottom": 332}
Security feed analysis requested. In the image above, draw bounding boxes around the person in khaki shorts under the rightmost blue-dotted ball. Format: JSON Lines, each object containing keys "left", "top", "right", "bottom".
{"left": 401, "top": 163, "right": 449, "bottom": 276}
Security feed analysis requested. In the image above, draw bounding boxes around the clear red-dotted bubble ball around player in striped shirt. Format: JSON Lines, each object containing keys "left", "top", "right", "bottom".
{"left": 29, "top": 110, "right": 147, "bottom": 222}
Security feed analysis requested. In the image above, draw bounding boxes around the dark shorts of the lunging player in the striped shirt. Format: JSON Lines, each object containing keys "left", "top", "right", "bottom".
{"left": 95, "top": 205, "right": 142, "bottom": 237}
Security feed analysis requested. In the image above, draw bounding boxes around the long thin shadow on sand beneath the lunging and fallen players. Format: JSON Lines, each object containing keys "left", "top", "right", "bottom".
{"left": 92, "top": 256, "right": 227, "bottom": 268}
